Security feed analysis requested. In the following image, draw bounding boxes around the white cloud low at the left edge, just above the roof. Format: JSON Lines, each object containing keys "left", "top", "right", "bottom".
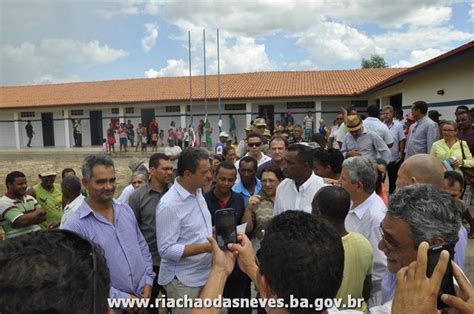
{"left": 0, "top": 39, "right": 128, "bottom": 85}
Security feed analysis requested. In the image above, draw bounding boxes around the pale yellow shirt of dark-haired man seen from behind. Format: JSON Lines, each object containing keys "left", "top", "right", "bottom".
{"left": 336, "top": 232, "right": 374, "bottom": 312}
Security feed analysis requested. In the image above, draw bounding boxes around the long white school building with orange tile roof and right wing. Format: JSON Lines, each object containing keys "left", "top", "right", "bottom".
{"left": 0, "top": 42, "right": 474, "bottom": 148}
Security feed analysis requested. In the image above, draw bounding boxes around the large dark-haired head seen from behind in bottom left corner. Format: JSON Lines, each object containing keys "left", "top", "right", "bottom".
{"left": 0, "top": 230, "right": 110, "bottom": 313}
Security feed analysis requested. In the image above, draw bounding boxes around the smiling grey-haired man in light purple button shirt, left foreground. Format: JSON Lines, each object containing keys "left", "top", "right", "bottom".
{"left": 63, "top": 155, "right": 155, "bottom": 310}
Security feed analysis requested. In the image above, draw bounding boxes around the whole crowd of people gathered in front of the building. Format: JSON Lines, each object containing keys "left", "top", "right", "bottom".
{"left": 0, "top": 101, "right": 474, "bottom": 313}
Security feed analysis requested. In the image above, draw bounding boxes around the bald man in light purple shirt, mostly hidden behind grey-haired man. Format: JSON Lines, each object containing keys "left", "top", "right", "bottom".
{"left": 375, "top": 154, "right": 467, "bottom": 306}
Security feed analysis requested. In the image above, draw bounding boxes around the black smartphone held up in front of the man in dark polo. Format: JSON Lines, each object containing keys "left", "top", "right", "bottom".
{"left": 214, "top": 208, "right": 237, "bottom": 251}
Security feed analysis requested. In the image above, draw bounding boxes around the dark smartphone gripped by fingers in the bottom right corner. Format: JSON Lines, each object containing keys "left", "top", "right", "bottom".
{"left": 426, "top": 244, "right": 456, "bottom": 310}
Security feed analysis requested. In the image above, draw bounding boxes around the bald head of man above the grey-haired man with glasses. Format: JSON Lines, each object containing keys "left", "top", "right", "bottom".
{"left": 396, "top": 154, "right": 446, "bottom": 188}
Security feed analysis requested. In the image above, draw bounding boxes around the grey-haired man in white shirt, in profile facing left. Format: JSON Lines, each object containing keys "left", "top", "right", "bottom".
{"left": 340, "top": 157, "right": 387, "bottom": 308}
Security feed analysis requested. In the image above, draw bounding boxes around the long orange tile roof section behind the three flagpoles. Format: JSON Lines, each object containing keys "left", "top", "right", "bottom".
{"left": 0, "top": 68, "right": 405, "bottom": 109}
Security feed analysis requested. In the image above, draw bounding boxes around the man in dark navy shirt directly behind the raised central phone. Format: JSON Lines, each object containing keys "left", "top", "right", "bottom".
{"left": 204, "top": 161, "right": 252, "bottom": 314}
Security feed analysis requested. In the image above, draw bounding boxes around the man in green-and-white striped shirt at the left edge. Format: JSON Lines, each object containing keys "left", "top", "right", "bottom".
{"left": 0, "top": 171, "right": 46, "bottom": 239}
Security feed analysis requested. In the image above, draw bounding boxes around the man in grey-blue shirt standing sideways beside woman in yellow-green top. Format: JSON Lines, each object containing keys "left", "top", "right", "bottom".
{"left": 405, "top": 101, "right": 439, "bottom": 159}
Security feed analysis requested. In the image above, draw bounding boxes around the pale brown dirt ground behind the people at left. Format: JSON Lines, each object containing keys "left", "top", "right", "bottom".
{"left": 0, "top": 149, "right": 159, "bottom": 198}
